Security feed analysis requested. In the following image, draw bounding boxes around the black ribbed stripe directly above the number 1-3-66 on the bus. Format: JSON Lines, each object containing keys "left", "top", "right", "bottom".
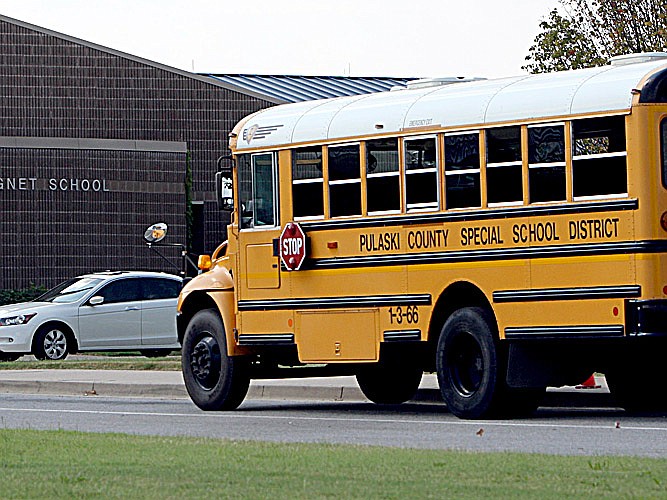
{"left": 238, "top": 293, "right": 431, "bottom": 311}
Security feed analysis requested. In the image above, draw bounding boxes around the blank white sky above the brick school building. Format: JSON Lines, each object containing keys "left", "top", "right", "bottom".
{"left": 0, "top": 0, "right": 558, "bottom": 77}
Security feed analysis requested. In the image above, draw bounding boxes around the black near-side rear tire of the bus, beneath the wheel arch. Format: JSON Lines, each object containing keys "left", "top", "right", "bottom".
{"left": 436, "top": 307, "right": 505, "bottom": 419}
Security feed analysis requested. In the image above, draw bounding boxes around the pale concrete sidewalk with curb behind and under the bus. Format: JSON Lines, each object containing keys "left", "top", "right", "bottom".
{"left": 0, "top": 370, "right": 611, "bottom": 407}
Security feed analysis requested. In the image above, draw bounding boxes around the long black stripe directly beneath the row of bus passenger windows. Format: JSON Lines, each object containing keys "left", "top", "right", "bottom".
{"left": 299, "top": 199, "right": 639, "bottom": 232}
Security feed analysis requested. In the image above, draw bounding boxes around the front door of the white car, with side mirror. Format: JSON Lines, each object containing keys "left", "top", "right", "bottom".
{"left": 79, "top": 278, "right": 141, "bottom": 349}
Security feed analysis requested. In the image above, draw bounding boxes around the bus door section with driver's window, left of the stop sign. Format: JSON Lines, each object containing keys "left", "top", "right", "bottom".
{"left": 237, "top": 153, "right": 280, "bottom": 290}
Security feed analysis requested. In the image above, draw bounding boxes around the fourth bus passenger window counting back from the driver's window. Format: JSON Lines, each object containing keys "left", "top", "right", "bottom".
{"left": 404, "top": 137, "right": 440, "bottom": 211}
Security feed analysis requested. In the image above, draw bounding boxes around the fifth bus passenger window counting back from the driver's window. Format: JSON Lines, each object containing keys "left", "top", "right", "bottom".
{"left": 445, "top": 132, "right": 482, "bottom": 208}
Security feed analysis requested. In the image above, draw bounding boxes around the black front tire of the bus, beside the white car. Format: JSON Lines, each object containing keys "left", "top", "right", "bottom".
{"left": 181, "top": 309, "right": 250, "bottom": 411}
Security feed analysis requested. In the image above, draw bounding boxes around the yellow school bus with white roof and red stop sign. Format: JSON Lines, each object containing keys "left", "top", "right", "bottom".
{"left": 178, "top": 53, "right": 667, "bottom": 418}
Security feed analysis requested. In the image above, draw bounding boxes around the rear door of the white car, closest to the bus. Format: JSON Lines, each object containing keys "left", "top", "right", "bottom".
{"left": 141, "top": 278, "right": 181, "bottom": 346}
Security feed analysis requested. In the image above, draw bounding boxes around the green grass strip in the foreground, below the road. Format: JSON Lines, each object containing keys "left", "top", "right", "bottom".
{"left": 0, "top": 429, "right": 667, "bottom": 499}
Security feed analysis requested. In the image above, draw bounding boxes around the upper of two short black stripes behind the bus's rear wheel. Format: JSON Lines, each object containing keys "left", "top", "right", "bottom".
{"left": 493, "top": 285, "right": 642, "bottom": 302}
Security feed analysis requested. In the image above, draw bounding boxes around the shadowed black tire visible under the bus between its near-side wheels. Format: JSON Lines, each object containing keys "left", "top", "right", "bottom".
{"left": 357, "top": 353, "right": 424, "bottom": 405}
